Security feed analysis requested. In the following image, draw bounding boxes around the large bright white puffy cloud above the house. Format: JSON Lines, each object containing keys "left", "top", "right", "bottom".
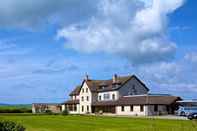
{"left": 58, "top": 0, "right": 183, "bottom": 64}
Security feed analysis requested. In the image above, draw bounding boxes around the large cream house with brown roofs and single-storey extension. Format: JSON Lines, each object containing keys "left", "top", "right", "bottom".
{"left": 62, "top": 75, "right": 180, "bottom": 116}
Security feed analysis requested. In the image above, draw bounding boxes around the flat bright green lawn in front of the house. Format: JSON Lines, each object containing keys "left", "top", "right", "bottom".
{"left": 0, "top": 114, "right": 197, "bottom": 131}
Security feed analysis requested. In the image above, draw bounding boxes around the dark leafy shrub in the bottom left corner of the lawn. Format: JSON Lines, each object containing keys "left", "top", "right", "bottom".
{"left": 0, "top": 121, "right": 25, "bottom": 131}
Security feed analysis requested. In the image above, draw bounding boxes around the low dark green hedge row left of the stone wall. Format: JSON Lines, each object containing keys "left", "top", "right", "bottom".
{"left": 0, "top": 108, "right": 32, "bottom": 113}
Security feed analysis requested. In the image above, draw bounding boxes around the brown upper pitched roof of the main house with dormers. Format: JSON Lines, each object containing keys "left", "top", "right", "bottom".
{"left": 70, "top": 75, "right": 149, "bottom": 96}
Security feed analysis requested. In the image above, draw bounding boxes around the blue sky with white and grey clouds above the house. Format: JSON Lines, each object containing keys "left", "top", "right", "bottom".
{"left": 0, "top": 0, "right": 197, "bottom": 104}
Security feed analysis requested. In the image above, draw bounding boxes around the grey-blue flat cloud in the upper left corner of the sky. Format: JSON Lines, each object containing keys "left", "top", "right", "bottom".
{"left": 0, "top": 0, "right": 97, "bottom": 28}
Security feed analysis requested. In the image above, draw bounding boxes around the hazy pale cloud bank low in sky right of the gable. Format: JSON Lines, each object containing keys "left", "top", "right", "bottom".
{"left": 135, "top": 53, "right": 197, "bottom": 98}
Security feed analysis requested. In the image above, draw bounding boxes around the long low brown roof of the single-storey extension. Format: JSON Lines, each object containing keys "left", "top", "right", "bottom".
{"left": 93, "top": 95, "right": 181, "bottom": 106}
